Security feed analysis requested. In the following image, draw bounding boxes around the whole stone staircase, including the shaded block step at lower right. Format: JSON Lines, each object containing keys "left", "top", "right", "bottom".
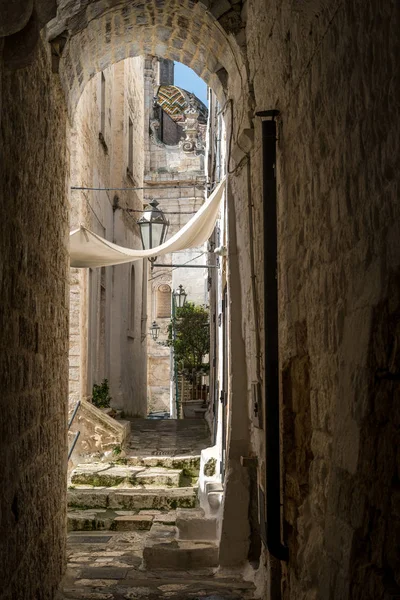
{"left": 68, "top": 456, "right": 218, "bottom": 569}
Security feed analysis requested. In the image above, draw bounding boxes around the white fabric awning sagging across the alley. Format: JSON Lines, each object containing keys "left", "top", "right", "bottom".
{"left": 70, "top": 178, "right": 225, "bottom": 268}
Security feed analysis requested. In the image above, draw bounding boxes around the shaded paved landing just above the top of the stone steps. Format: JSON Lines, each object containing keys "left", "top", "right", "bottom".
{"left": 129, "top": 419, "right": 211, "bottom": 456}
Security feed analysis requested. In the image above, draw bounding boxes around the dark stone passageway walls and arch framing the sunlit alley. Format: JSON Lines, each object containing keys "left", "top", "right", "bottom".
{"left": 0, "top": 0, "right": 400, "bottom": 600}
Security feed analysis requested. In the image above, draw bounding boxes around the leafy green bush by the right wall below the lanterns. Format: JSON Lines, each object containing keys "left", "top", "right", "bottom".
{"left": 167, "top": 302, "right": 210, "bottom": 372}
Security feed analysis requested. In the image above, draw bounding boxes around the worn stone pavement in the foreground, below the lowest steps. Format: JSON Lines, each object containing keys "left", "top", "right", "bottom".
{"left": 56, "top": 531, "right": 253, "bottom": 600}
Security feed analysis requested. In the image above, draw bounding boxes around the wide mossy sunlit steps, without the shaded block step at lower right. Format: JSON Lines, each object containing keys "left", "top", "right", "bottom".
{"left": 68, "top": 456, "right": 200, "bottom": 520}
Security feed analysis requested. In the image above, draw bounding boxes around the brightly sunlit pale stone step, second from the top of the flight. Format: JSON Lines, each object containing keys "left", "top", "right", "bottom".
{"left": 71, "top": 463, "right": 185, "bottom": 488}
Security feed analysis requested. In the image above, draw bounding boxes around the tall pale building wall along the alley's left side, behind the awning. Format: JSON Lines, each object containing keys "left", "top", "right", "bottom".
{"left": 69, "top": 57, "right": 147, "bottom": 415}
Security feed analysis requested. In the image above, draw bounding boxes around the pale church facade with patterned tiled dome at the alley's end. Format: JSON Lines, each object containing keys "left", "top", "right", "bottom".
{"left": 144, "top": 56, "right": 208, "bottom": 416}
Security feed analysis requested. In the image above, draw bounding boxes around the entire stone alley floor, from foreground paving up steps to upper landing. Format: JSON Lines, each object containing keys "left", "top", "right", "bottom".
{"left": 57, "top": 419, "right": 254, "bottom": 600}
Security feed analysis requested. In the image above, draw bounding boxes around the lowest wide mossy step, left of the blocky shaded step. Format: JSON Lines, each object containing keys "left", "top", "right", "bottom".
{"left": 67, "top": 509, "right": 176, "bottom": 531}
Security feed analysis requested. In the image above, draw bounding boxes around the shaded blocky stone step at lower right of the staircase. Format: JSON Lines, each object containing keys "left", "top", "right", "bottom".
{"left": 143, "top": 524, "right": 218, "bottom": 571}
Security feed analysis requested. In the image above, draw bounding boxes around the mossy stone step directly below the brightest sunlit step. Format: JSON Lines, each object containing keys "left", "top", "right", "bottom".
{"left": 67, "top": 486, "right": 197, "bottom": 512}
